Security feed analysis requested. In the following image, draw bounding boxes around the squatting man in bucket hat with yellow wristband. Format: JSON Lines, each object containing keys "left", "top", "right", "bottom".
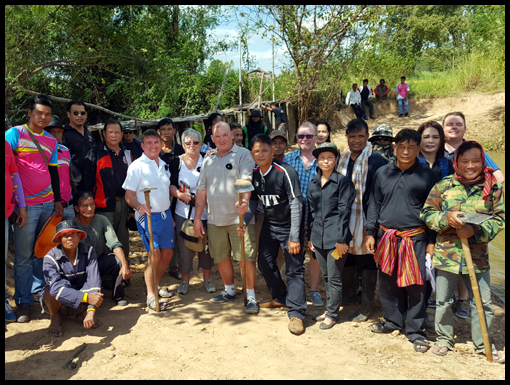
{"left": 43, "top": 219, "right": 103, "bottom": 337}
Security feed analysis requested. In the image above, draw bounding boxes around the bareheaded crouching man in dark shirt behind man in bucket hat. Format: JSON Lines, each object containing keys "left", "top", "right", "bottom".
{"left": 74, "top": 192, "right": 131, "bottom": 305}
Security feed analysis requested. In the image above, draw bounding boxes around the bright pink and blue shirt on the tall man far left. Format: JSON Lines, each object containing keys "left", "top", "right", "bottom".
{"left": 5, "top": 124, "right": 58, "bottom": 206}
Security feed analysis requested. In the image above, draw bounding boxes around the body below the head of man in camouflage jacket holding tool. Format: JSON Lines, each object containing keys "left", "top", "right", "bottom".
{"left": 421, "top": 141, "right": 505, "bottom": 362}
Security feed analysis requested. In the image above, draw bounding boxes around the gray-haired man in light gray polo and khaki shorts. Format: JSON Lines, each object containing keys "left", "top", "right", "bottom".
{"left": 194, "top": 122, "right": 259, "bottom": 314}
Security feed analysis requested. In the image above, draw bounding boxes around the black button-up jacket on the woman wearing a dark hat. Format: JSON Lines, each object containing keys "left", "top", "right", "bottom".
{"left": 307, "top": 170, "right": 356, "bottom": 250}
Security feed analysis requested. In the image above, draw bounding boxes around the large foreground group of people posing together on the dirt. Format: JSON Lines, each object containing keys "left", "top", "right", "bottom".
{"left": 6, "top": 96, "right": 504, "bottom": 362}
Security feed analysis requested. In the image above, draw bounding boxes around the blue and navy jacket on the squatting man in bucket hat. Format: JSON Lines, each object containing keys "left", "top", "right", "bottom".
{"left": 43, "top": 242, "right": 101, "bottom": 309}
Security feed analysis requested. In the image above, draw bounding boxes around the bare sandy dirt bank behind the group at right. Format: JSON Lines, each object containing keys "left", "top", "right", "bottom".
{"left": 332, "top": 92, "right": 505, "bottom": 149}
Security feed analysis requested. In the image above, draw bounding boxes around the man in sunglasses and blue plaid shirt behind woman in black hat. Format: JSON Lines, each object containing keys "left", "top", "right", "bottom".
{"left": 283, "top": 122, "right": 324, "bottom": 306}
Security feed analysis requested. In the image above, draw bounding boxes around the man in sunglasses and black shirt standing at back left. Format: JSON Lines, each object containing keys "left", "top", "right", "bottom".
{"left": 62, "top": 100, "right": 94, "bottom": 193}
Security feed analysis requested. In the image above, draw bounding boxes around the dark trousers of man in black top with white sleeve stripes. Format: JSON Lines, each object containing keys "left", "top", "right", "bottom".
{"left": 258, "top": 222, "right": 307, "bottom": 320}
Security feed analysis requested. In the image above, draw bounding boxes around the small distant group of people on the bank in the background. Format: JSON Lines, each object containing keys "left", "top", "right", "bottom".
{"left": 345, "top": 76, "right": 411, "bottom": 120}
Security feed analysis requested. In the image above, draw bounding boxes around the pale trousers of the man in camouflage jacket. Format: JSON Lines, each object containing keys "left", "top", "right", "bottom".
{"left": 435, "top": 270, "right": 495, "bottom": 353}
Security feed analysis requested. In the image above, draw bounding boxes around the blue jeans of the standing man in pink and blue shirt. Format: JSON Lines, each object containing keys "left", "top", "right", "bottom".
{"left": 14, "top": 201, "right": 54, "bottom": 305}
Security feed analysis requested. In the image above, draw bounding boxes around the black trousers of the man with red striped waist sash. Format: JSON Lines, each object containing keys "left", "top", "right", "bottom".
{"left": 378, "top": 230, "right": 428, "bottom": 342}
